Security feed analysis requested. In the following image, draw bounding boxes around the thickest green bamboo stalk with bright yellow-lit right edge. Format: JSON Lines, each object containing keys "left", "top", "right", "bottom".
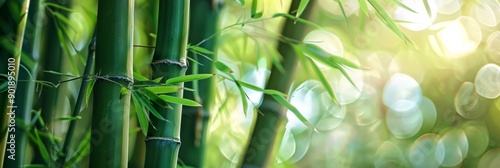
{"left": 89, "top": 0, "right": 134, "bottom": 168}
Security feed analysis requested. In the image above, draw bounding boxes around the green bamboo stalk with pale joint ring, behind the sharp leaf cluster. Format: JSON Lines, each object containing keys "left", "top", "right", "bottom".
{"left": 145, "top": 0, "right": 190, "bottom": 168}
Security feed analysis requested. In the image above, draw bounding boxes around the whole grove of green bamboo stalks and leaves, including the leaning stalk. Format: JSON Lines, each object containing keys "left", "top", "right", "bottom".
{"left": 0, "top": 0, "right": 472, "bottom": 168}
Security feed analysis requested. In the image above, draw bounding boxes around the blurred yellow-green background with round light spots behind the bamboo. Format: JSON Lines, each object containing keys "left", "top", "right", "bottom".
{"left": 0, "top": 0, "right": 500, "bottom": 167}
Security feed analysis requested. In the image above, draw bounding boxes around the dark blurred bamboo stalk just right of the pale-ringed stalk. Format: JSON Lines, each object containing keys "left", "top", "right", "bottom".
{"left": 179, "top": 0, "right": 220, "bottom": 167}
